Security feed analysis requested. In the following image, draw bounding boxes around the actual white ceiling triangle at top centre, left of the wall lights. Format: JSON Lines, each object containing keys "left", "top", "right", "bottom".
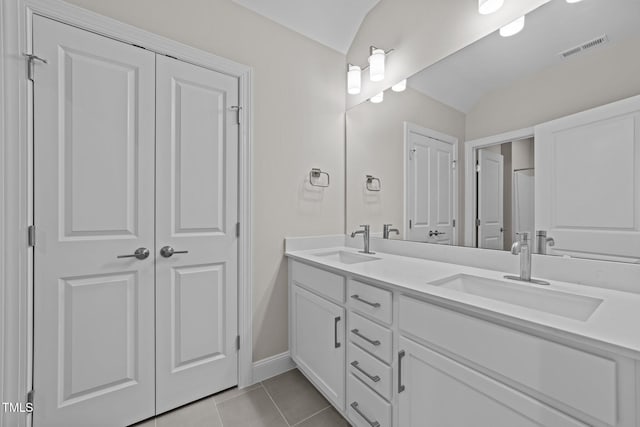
{"left": 233, "top": 0, "right": 380, "bottom": 54}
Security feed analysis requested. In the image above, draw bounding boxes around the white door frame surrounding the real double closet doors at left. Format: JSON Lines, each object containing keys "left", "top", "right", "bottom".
{"left": 0, "top": 0, "right": 253, "bottom": 426}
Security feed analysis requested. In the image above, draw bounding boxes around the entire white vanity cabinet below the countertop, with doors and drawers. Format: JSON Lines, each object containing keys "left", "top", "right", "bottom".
{"left": 290, "top": 260, "right": 640, "bottom": 427}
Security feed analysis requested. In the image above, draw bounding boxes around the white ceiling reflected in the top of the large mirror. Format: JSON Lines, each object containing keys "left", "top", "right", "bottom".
{"left": 408, "top": 0, "right": 640, "bottom": 113}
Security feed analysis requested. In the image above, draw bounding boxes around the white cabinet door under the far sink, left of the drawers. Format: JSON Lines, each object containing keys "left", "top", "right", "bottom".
{"left": 291, "top": 285, "right": 345, "bottom": 410}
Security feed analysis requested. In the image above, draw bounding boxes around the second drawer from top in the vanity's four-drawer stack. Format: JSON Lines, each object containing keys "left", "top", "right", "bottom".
{"left": 349, "top": 312, "right": 393, "bottom": 363}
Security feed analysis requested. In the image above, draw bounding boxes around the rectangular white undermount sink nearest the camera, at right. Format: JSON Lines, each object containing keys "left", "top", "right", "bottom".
{"left": 430, "top": 274, "right": 602, "bottom": 321}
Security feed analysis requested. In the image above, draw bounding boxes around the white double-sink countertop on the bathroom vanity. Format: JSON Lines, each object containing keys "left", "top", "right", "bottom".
{"left": 286, "top": 247, "right": 640, "bottom": 360}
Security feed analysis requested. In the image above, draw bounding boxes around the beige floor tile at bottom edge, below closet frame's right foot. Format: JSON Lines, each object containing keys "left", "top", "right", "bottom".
{"left": 218, "top": 387, "right": 287, "bottom": 427}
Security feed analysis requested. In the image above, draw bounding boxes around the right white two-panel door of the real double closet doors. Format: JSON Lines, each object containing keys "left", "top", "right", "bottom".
{"left": 156, "top": 55, "right": 239, "bottom": 413}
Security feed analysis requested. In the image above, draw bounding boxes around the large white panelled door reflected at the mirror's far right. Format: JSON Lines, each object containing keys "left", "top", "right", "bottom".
{"left": 535, "top": 96, "right": 640, "bottom": 262}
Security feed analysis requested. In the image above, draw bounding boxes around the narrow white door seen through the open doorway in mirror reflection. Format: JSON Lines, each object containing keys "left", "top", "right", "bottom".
{"left": 478, "top": 150, "right": 504, "bottom": 250}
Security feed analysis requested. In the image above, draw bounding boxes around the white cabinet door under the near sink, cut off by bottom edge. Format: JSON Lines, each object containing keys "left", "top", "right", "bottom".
{"left": 398, "top": 337, "right": 586, "bottom": 427}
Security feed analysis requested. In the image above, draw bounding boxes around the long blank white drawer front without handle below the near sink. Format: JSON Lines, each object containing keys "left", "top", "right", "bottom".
{"left": 399, "top": 296, "right": 619, "bottom": 425}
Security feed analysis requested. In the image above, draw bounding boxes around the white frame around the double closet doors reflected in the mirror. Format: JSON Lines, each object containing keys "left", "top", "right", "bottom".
{"left": 402, "top": 122, "right": 459, "bottom": 246}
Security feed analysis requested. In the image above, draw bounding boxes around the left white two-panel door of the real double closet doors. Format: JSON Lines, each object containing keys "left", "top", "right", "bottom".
{"left": 33, "top": 16, "right": 155, "bottom": 427}
